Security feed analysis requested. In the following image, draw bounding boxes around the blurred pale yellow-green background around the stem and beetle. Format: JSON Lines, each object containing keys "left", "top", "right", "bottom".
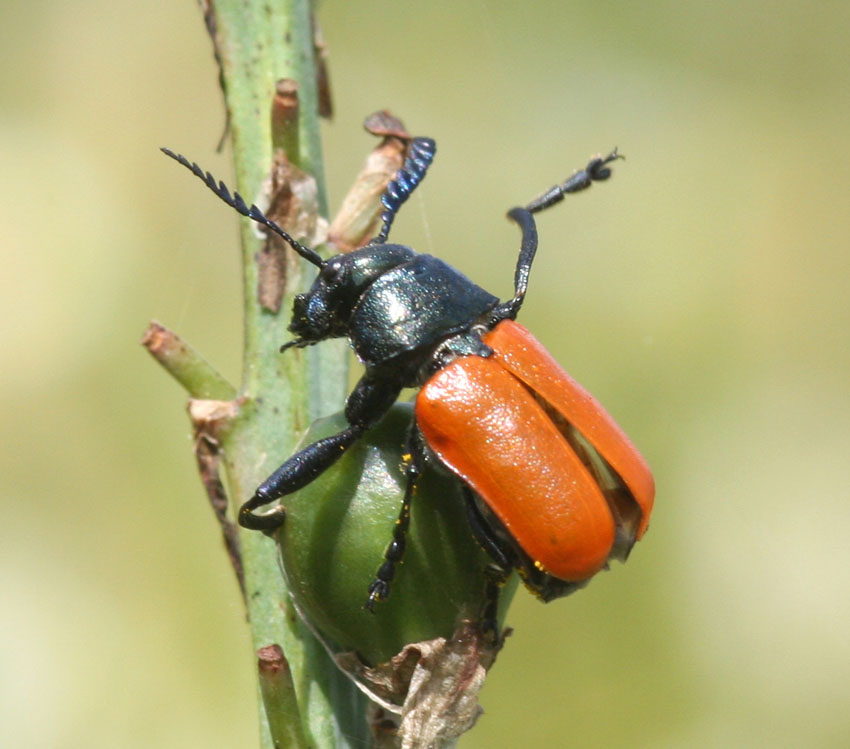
{"left": 0, "top": 0, "right": 850, "bottom": 749}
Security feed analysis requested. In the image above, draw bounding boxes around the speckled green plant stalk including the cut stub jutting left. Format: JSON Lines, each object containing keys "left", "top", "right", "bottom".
{"left": 153, "top": 0, "right": 369, "bottom": 749}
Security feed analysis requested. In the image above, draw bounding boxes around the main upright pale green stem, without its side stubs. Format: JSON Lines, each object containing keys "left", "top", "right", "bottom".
{"left": 202, "top": 0, "right": 366, "bottom": 747}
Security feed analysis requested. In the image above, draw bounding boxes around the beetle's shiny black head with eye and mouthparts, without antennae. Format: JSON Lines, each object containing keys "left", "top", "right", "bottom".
{"left": 285, "top": 244, "right": 416, "bottom": 347}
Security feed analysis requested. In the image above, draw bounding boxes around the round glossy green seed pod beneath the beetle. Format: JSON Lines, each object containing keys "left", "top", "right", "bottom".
{"left": 277, "top": 404, "right": 516, "bottom": 665}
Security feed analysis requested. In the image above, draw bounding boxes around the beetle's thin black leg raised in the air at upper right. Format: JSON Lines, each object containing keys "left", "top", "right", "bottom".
{"left": 490, "top": 148, "right": 625, "bottom": 325}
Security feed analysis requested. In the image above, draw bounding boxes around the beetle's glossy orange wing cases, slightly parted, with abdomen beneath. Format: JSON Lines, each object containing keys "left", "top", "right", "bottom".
{"left": 415, "top": 320, "right": 655, "bottom": 601}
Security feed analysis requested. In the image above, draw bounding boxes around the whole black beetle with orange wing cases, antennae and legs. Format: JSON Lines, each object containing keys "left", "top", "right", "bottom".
{"left": 162, "top": 138, "right": 655, "bottom": 610}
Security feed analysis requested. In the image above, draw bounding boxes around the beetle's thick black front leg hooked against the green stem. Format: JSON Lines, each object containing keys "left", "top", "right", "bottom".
{"left": 238, "top": 373, "right": 401, "bottom": 532}
